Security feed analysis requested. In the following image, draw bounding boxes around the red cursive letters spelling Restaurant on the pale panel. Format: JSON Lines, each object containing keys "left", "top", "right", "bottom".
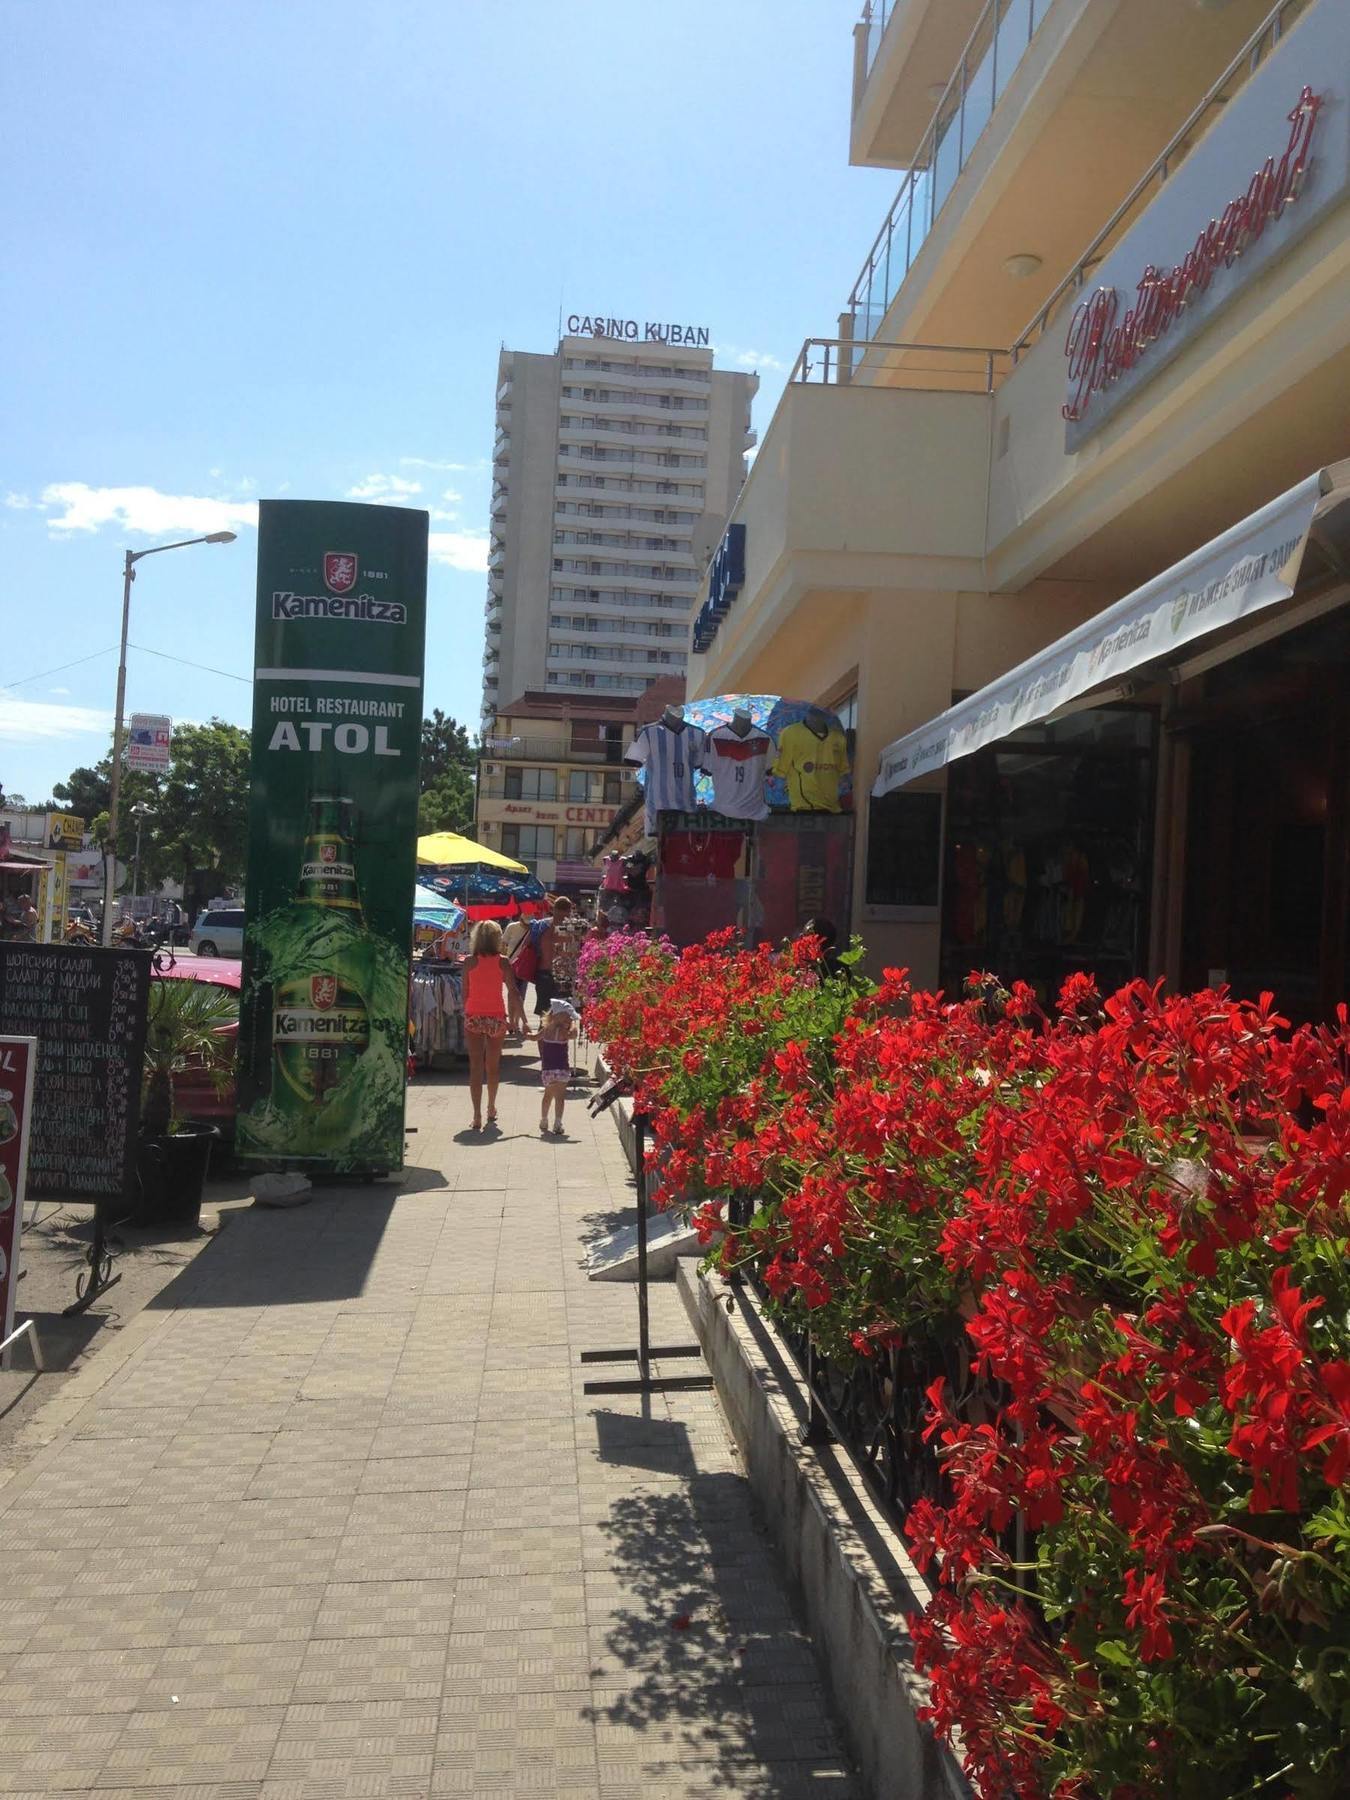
{"left": 1060, "top": 86, "right": 1323, "bottom": 419}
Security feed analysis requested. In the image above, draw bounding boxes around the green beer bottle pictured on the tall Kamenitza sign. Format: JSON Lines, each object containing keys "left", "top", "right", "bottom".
{"left": 272, "top": 796, "right": 371, "bottom": 1123}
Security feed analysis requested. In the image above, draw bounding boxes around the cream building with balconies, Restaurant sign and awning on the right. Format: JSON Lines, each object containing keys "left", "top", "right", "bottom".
{"left": 689, "top": 0, "right": 1350, "bottom": 1017}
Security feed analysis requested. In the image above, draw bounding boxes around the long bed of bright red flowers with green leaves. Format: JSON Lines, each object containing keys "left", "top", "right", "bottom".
{"left": 589, "top": 934, "right": 1350, "bottom": 1800}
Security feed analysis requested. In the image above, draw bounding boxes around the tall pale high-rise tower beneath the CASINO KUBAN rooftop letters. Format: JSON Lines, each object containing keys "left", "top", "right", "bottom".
{"left": 482, "top": 331, "right": 760, "bottom": 731}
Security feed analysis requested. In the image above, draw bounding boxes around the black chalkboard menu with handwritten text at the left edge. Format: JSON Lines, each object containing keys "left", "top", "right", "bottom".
{"left": 0, "top": 943, "right": 151, "bottom": 1199}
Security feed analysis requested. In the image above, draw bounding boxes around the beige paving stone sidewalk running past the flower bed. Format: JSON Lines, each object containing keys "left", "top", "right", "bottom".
{"left": 0, "top": 1055, "right": 859, "bottom": 1800}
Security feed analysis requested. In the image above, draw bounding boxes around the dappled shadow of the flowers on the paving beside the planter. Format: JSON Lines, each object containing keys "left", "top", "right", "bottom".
{"left": 585, "top": 1413, "right": 851, "bottom": 1800}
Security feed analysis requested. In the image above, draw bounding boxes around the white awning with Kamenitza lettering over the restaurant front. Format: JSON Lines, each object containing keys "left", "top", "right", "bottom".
{"left": 871, "top": 464, "right": 1346, "bottom": 794}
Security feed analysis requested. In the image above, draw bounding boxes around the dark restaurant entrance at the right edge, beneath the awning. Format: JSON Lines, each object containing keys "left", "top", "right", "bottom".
{"left": 1175, "top": 610, "right": 1350, "bottom": 1024}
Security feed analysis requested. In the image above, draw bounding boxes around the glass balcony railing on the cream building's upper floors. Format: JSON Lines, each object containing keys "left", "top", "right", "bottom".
{"left": 848, "top": 0, "right": 1053, "bottom": 340}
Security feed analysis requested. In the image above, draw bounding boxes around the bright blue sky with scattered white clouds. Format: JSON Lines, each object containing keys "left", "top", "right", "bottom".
{"left": 0, "top": 0, "right": 896, "bottom": 801}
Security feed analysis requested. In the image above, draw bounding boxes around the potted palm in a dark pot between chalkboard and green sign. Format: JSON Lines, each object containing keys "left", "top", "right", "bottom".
{"left": 137, "top": 981, "right": 238, "bottom": 1224}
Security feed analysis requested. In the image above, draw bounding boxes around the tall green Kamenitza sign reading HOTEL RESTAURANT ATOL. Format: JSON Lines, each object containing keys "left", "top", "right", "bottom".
{"left": 236, "top": 500, "right": 427, "bottom": 1174}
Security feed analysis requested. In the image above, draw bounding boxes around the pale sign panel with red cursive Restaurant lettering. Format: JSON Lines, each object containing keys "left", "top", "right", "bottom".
{"left": 1062, "top": 5, "right": 1350, "bottom": 452}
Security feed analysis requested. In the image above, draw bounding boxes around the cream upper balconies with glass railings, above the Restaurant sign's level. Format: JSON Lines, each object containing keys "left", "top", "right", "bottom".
{"left": 842, "top": 0, "right": 1288, "bottom": 358}
